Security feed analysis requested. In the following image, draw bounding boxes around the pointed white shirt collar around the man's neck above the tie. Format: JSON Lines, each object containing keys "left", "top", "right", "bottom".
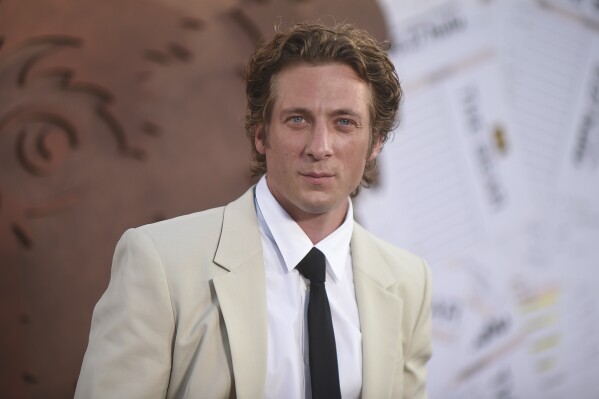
{"left": 256, "top": 176, "right": 354, "bottom": 280}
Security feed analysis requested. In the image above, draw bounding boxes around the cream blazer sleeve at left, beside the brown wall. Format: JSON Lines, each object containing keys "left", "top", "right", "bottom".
{"left": 75, "top": 229, "right": 175, "bottom": 399}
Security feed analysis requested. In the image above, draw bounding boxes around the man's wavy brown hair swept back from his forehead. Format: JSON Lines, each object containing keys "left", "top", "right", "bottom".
{"left": 245, "top": 23, "right": 403, "bottom": 195}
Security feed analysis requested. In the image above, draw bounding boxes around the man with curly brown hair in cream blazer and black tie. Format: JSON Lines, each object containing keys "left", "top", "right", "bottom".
{"left": 76, "top": 24, "right": 431, "bottom": 399}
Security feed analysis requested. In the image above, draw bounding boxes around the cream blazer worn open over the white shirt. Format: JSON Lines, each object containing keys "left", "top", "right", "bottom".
{"left": 75, "top": 188, "right": 431, "bottom": 399}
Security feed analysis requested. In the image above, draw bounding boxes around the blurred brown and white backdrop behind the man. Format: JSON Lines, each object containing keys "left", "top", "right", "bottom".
{"left": 0, "top": 0, "right": 599, "bottom": 399}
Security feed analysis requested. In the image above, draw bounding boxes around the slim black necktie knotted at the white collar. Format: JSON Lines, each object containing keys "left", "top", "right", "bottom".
{"left": 297, "top": 247, "right": 341, "bottom": 399}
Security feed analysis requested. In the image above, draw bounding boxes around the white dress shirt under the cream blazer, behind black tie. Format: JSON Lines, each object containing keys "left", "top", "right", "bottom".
{"left": 256, "top": 176, "right": 362, "bottom": 399}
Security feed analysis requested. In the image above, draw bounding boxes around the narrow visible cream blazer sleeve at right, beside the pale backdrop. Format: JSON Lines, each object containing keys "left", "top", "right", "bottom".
{"left": 404, "top": 261, "right": 432, "bottom": 399}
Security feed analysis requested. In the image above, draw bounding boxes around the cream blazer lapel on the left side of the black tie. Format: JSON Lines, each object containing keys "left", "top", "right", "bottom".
{"left": 213, "top": 188, "right": 268, "bottom": 398}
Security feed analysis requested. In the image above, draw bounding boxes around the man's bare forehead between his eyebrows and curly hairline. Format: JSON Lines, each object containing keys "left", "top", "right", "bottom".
{"left": 272, "top": 63, "right": 371, "bottom": 113}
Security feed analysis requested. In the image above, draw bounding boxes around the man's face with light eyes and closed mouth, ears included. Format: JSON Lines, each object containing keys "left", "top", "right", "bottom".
{"left": 256, "top": 63, "right": 380, "bottom": 221}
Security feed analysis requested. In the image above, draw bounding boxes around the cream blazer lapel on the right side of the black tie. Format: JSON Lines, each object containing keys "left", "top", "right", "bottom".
{"left": 351, "top": 223, "right": 403, "bottom": 398}
